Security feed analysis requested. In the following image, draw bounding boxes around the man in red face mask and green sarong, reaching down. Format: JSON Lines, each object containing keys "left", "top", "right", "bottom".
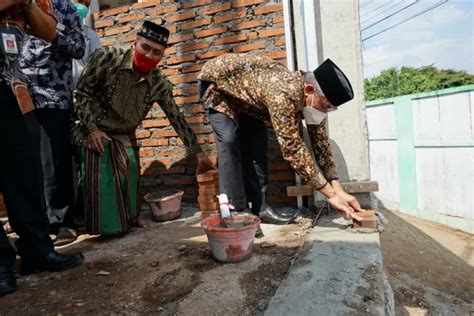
{"left": 73, "top": 21, "right": 212, "bottom": 234}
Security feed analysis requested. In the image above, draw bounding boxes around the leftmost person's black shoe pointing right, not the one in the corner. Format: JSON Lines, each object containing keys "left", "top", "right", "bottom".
{"left": 20, "top": 251, "right": 84, "bottom": 275}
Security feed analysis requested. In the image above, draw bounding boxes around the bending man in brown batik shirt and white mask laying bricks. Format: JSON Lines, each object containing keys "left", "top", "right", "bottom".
{"left": 199, "top": 54, "right": 361, "bottom": 223}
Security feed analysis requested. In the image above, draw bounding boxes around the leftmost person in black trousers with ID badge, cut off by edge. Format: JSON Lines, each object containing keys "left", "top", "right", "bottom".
{"left": 0, "top": 0, "right": 83, "bottom": 296}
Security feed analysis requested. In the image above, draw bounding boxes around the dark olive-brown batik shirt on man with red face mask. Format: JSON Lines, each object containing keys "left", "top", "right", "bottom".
{"left": 73, "top": 47, "right": 202, "bottom": 154}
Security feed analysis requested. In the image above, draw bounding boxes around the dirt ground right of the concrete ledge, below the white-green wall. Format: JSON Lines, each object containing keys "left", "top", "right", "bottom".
{"left": 381, "top": 212, "right": 474, "bottom": 316}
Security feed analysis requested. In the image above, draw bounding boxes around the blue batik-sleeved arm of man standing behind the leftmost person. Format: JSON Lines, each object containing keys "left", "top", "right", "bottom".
{"left": 55, "top": 1, "right": 86, "bottom": 59}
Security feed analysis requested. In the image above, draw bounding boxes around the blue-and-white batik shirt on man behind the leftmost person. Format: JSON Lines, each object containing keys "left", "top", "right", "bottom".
{"left": 20, "top": 0, "right": 85, "bottom": 110}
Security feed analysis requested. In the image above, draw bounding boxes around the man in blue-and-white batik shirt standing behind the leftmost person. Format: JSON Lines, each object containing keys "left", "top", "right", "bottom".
{"left": 20, "top": 0, "right": 85, "bottom": 246}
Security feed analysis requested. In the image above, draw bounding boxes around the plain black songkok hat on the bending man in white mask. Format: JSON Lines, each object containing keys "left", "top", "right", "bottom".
{"left": 313, "top": 59, "right": 354, "bottom": 106}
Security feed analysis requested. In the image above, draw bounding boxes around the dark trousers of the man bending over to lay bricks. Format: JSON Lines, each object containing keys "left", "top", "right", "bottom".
{"left": 209, "top": 108, "right": 268, "bottom": 214}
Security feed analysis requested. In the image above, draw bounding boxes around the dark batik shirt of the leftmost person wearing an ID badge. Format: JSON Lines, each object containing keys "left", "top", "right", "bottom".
{"left": 0, "top": 0, "right": 54, "bottom": 86}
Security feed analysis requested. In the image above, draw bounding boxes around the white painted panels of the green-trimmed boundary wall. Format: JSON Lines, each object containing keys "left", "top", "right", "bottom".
{"left": 367, "top": 91, "right": 474, "bottom": 233}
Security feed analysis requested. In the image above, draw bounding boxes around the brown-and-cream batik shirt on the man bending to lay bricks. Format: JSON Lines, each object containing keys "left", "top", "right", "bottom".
{"left": 199, "top": 54, "right": 338, "bottom": 189}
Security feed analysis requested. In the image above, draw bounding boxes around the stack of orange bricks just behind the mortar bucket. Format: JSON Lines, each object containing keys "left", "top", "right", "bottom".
{"left": 196, "top": 170, "right": 219, "bottom": 219}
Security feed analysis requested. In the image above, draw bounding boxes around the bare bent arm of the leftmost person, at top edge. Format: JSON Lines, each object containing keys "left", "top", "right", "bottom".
{"left": 20, "top": 0, "right": 58, "bottom": 42}
